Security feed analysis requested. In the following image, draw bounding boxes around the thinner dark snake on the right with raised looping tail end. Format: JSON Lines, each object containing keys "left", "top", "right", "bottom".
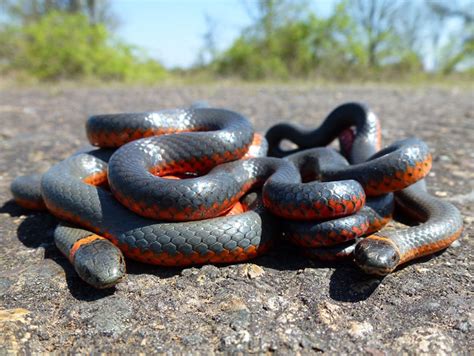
{"left": 266, "top": 102, "right": 463, "bottom": 276}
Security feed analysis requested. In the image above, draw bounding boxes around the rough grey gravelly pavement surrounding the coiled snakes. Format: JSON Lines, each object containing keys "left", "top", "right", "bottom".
{"left": 0, "top": 85, "right": 474, "bottom": 355}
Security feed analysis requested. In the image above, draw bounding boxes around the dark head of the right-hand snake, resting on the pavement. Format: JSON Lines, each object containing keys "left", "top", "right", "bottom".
{"left": 354, "top": 235, "right": 400, "bottom": 276}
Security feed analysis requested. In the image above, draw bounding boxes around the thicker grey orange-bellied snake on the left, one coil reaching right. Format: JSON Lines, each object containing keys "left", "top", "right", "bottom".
{"left": 7, "top": 107, "right": 372, "bottom": 288}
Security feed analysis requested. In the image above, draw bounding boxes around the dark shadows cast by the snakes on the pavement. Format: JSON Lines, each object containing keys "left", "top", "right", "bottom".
{"left": 0, "top": 200, "right": 381, "bottom": 302}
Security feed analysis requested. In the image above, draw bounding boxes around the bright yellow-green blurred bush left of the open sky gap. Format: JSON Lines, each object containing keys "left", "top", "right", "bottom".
{"left": 0, "top": 1, "right": 166, "bottom": 82}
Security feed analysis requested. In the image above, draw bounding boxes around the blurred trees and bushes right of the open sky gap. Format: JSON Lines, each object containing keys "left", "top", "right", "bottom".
{"left": 212, "top": 0, "right": 474, "bottom": 80}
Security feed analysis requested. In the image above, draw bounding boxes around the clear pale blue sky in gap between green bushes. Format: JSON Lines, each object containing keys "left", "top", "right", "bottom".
{"left": 115, "top": 0, "right": 336, "bottom": 68}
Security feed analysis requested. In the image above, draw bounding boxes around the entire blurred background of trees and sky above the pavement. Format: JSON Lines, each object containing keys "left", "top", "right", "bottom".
{"left": 0, "top": 0, "right": 474, "bottom": 84}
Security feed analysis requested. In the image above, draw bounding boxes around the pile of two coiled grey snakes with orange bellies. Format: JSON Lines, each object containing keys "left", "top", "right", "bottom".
{"left": 11, "top": 103, "right": 462, "bottom": 288}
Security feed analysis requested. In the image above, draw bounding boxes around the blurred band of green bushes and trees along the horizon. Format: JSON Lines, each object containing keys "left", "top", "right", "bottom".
{"left": 0, "top": 0, "right": 474, "bottom": 83}
